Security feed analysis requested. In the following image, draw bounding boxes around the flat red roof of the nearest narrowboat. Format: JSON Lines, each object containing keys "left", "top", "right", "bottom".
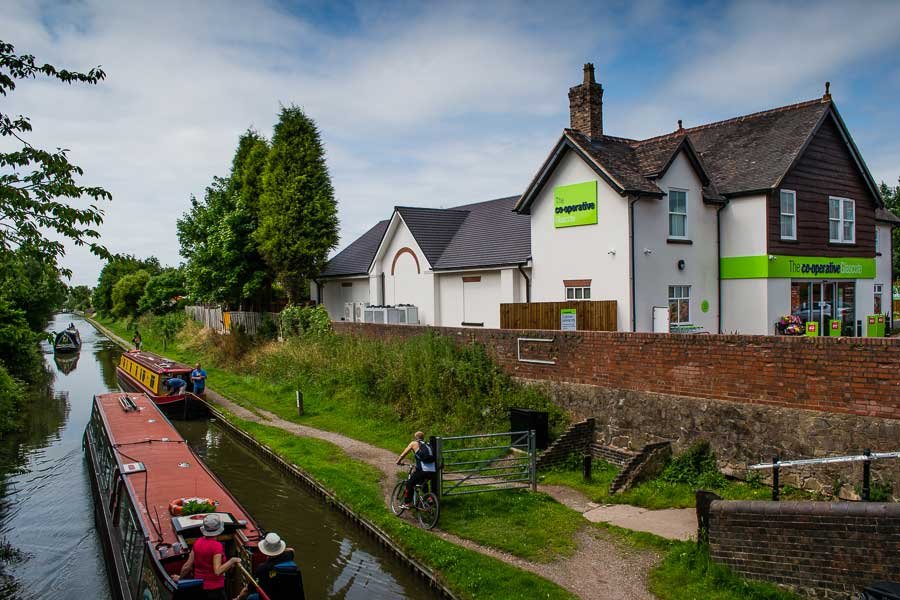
{"left": 94, "top": 392, "right": 260, "bottom": 546}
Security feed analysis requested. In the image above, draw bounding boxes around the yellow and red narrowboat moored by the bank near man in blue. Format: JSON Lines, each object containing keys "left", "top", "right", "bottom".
{"left": 116, "top": 350, "right": 193, "bottom": 414}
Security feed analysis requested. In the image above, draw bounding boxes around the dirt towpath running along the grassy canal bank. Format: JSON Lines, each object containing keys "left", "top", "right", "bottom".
{"left": 88, "top": 324, "right": 660, "bottom": 600}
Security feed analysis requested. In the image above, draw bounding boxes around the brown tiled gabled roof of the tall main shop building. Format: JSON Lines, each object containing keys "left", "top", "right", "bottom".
{"left": 516, "top": 97, "right": 880, "bottom": 212}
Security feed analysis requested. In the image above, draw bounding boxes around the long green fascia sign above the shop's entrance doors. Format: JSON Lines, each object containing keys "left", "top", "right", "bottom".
{"left": 720, "top": 255, "right": 875, "bottom": 279}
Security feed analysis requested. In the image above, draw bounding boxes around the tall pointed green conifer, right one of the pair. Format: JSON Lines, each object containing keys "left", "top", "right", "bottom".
{"left": 254, "top": 106, "right": 338, "bottom": 302}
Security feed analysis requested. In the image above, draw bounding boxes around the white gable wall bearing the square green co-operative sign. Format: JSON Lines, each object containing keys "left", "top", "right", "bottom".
{"left": 531, "top": 152, "right": 631, "bottom": 331}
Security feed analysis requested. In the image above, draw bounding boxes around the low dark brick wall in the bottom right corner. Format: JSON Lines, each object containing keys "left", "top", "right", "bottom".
{"left": 709, "top": 501, "right": 900, "bottom": 600}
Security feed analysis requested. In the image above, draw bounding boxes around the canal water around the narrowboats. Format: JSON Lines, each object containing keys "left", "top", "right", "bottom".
{"left": 0, "top": 315, "right": 432, "bottom": 600}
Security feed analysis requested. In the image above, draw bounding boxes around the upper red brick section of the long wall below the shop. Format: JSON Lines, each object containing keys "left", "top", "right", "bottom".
{"left": 335, "top": 323, "right": 900, "bottom": 419}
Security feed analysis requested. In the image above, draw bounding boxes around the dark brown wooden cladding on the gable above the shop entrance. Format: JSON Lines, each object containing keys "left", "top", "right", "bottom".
{"left": 768, "top": 116, "right": 876, "bottom": 258}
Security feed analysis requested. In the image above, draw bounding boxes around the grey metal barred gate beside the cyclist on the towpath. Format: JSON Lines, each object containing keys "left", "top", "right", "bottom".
{"left": 434, "top": 430, "right": 537, "bottom": 496}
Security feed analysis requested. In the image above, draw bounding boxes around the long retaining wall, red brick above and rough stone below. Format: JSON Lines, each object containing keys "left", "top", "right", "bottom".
{"left": 335, "top": 323, "right": 900, "bottom": 498}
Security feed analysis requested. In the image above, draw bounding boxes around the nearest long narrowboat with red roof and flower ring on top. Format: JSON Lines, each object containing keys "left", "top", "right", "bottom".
{"left": 84, "top": 392, "right": 303, "bottom": 600}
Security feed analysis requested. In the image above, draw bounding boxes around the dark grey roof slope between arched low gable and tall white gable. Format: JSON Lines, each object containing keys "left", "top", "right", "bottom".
{"left": 432, "top": 196, "right": 531, "bottom": 270}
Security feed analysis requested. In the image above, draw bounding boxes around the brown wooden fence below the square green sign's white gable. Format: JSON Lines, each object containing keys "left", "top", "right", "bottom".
{"left": 500, "top": 300, "right": 618, "bottom": 331}
